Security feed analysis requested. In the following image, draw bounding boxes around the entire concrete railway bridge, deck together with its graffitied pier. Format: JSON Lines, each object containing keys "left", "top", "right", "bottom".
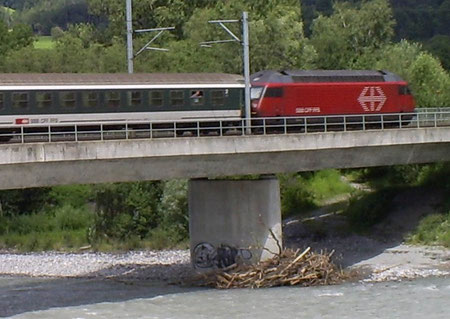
{"left": 0, "top": 112, "right": 450, "bottom": 268}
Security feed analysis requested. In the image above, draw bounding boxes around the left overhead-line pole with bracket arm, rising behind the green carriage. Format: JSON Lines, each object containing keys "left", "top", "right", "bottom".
{"left": 127, "top": 0, "right": 175, "bottom": 74}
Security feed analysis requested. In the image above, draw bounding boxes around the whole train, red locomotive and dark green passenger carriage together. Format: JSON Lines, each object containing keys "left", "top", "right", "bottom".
{"left": 0, "top": 70, "right": 415, "bottom": 141}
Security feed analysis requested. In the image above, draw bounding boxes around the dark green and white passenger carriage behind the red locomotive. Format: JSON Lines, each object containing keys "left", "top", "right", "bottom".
{"left": 0, "top": 73, "right": 244, "bottom": 141}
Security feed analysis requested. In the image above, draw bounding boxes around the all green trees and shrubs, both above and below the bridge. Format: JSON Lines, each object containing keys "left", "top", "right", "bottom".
{"left": 0, "top": 0, "right": 450, "bottom": 250}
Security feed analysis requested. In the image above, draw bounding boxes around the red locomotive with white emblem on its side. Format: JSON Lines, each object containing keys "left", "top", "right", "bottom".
{"left": 251, "top": 70, "right": 415, "bottom": 117}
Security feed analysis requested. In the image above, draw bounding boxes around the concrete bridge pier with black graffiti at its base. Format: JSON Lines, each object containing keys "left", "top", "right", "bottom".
{"left": 189, "top": 176, "right": 282, "bottom": 270}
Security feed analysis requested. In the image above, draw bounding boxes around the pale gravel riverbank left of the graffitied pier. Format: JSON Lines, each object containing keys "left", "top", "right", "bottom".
{"left": 0, "top": 250, "right": 191, "bottom": 281}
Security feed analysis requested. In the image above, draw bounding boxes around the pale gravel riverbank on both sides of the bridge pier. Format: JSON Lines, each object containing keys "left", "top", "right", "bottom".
{"left": 0, "top": 242, "right": 450, "bottom": 283}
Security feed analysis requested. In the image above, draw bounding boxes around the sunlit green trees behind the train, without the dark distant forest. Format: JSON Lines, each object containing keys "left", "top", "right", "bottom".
{"left": 0, "top": 0, "right": 450, "bottom": 107}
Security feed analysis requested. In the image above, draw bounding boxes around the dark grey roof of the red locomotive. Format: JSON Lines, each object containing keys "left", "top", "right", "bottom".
{"left": 251, "top": 70, "right": 403, "bottom": 83}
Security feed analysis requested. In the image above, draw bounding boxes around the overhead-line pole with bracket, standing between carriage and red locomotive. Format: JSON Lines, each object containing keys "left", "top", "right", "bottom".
{"left": 200, "top": 11, "right": 251, "bottom": 134}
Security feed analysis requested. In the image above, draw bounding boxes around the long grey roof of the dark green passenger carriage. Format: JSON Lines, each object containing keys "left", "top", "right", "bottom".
{"left": 0, "top": 73, "right": 244, "bottom": 90}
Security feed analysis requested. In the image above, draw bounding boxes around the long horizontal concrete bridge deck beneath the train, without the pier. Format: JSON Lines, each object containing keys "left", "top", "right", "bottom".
{"left": 0, "top": 127, "right": 450, "bottom": 189}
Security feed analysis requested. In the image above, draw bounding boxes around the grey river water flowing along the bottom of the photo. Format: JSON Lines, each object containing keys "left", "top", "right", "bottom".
{"left": 0, "top": 277, "right": 450, "bottom": 319}
